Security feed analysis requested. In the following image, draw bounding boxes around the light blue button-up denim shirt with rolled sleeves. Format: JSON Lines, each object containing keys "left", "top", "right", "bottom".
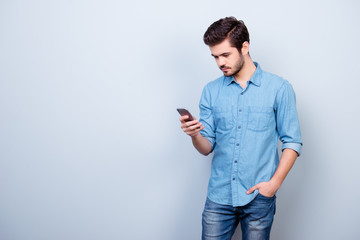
{"left": 199, "top": 63, "right": 302, "bottom": 207}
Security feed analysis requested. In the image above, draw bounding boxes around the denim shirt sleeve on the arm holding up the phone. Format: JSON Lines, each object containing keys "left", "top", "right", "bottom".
{"left": 199, "top": 86, "right": 215, "bottom": 151}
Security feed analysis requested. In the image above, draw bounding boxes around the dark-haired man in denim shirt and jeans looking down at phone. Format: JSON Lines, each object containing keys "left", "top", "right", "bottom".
{"left": 180, "top": 17, "right": 302, "bottom": 240}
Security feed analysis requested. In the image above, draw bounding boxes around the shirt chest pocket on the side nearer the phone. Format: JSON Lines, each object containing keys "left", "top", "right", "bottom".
{"left": 213, "top": 106, "right": 234, "bottom": 131}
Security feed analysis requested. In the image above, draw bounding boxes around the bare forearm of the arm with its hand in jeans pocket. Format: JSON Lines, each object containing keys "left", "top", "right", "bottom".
{"left": 270, "top": 148, "right": 298, "bottom": 189}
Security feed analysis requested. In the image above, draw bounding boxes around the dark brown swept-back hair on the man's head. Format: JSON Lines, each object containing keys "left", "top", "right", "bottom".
{"left": 204, "top": 17, "right": 250, "bottom": 52}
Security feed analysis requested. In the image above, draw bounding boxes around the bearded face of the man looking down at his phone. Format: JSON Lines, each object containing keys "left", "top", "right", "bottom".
{"left": 210, "top": 39, "right": 244, "bottom": 77}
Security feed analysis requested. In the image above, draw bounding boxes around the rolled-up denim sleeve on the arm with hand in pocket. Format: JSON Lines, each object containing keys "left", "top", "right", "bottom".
{"left": 275, "top": 81, "right": 303, "bottom": 156}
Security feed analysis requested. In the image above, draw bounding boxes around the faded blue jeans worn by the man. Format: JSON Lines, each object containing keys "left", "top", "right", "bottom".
{"left": 202, "top": 194, "right": 276, "bottom": 240}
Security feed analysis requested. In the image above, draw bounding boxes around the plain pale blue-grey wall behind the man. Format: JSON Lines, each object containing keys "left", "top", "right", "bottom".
{"left": 0, "top": 0, "right": 360, "bottom": 240}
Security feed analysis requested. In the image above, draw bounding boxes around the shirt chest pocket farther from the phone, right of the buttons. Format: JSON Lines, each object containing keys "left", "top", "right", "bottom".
{"left": 247, "top": 106, "right": 275, "bottom": 131}
